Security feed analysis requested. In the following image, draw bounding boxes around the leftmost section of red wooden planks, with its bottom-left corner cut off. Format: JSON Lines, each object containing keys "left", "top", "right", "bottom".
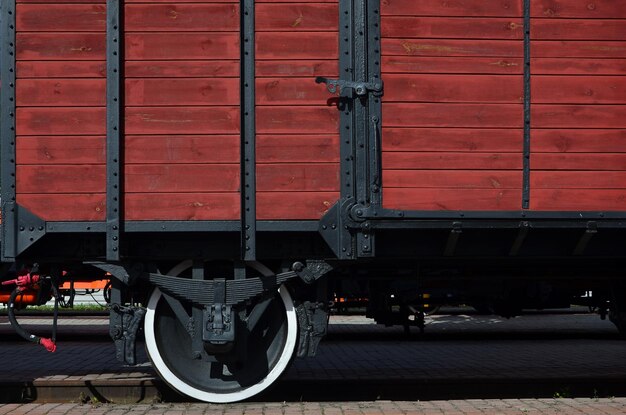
{"left": 15, "top": 0, "right": 106, "bottom": 221}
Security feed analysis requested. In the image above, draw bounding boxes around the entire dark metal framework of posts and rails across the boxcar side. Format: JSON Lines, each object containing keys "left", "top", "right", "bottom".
{"left": 0, "top": 0, "right": 626, "bottom": 262}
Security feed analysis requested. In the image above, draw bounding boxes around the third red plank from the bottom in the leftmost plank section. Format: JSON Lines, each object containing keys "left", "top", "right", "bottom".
{"left": 16, "top": 136, "right": 106, "bottom": 165}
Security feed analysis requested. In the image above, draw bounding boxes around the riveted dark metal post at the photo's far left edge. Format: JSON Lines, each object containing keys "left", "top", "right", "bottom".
{"left": 0, "top": 0, "right": 17, "bottom": 260}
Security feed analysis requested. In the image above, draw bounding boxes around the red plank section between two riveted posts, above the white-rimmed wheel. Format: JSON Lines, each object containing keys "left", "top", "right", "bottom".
{"left": 124, "top": 1, "right": 241, "bottom": 220}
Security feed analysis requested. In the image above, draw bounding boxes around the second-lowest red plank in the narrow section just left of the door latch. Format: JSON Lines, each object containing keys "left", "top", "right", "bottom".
{"left": 256, "top": 163, "right": 339, "bottom": 192}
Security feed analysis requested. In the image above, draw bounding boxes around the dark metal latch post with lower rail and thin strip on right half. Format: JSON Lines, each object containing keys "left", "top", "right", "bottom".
{"left": 319, "top": 0, "right": 626, "bottom": 259}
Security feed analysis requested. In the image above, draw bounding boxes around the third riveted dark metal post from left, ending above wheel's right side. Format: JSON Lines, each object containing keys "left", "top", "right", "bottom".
{"left": 240, "top": 0, "right": 256, "bottom": 261}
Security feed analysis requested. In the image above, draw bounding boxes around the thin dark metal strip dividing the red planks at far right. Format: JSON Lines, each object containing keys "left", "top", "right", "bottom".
{"left": 522, "top": 0, "right": 531, "bottom": 209}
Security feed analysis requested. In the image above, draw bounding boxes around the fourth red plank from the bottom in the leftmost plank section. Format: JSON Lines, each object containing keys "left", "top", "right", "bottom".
{"left": 16, "top": 107, "right": 106, "bottom": 136}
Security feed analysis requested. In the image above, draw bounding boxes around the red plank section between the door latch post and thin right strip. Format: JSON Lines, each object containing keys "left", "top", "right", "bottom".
{"left": 381, "top": 0, "right": 524, "bottom": 210}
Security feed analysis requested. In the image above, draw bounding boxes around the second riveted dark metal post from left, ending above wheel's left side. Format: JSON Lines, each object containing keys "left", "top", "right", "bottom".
{"left": 106, "top": 0, "right": 123, "bottom": 261}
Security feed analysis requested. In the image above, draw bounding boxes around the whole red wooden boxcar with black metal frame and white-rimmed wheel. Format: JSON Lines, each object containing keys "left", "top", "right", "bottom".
{"left": 0, "top": 0, "right": 626, "bottom": 402}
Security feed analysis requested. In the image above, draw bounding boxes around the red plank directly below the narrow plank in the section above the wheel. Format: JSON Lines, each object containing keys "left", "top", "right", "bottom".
{"left": 125, "top": 78, "right": 241, "bottom": 106}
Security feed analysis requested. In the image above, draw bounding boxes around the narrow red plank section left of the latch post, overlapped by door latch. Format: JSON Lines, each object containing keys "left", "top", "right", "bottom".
{"left": 255, "top": 0, "right": 339, "bottom": 220}
